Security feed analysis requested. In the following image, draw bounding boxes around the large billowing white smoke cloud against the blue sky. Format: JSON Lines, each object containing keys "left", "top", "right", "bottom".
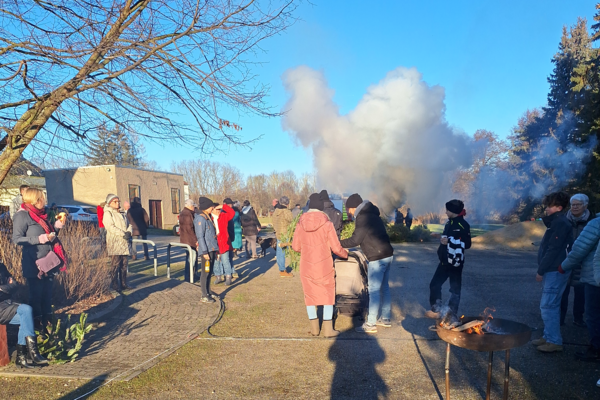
{"left": 283, "top": 66, "right": 472, "bottom": 213}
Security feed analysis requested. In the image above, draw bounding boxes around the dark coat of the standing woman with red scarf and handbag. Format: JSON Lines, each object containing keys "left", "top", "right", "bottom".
{"left": 13, "top": 210, "right": 52, "bottom": 278}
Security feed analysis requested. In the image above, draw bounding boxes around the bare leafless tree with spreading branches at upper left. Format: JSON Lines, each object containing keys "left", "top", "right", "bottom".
{"left": 0, "top": 0, "right": 297, "bottom": 183}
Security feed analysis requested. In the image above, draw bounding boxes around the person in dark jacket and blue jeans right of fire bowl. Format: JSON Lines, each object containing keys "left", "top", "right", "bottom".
{"left": 532, "top": 192, "right": 573, "bottom": 353}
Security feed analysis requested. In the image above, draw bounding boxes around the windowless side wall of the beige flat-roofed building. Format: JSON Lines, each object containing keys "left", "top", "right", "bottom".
{"left": 44, "top": 165, "right": 117, "bottom": 206}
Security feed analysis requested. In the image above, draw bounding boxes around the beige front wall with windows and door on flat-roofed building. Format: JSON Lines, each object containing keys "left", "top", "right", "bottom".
{"left": 116, "top": 167, "right": 185, "bottom": 229}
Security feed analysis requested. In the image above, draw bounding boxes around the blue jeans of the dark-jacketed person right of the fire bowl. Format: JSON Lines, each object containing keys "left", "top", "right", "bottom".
{"left": 540, "top": 271, "right": 570, "bottom": 346}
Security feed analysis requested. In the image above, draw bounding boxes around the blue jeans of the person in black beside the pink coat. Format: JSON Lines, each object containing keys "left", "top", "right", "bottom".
{"left": 367, "top": 256, "right": 394, "bottom": 325}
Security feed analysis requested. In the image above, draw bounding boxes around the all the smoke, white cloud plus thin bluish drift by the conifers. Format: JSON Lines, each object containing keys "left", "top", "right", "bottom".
{"left": 283, "top": 66, "right": 596, "bottom": 221}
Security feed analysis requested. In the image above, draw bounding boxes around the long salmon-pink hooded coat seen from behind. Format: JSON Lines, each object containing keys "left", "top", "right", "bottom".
{"left": 292, "top": 210, "right": 348, "bottom": 306}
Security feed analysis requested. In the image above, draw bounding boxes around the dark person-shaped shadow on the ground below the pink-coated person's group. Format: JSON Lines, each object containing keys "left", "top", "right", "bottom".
{"left": 329, "top": 333, "right": 389, "bottom": 400}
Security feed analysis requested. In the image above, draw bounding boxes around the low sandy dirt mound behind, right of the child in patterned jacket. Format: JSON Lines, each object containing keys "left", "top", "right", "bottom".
{"left": 473, "top": 221, "right": 546, "bottom": 251}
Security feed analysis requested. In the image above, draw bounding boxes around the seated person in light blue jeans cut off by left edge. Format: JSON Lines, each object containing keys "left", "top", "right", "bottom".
{"left": 0, "top": 263, "right": 48, "bottom": 368}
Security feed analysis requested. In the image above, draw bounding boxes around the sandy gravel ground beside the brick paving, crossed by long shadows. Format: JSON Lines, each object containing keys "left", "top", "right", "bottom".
{"left": 0, "top": 244, "right": 600, "bottom": 399}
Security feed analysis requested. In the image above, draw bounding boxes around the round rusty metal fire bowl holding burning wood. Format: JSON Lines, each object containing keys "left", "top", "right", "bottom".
{"left": 436, "top": 317, "right": 531, "bottom": 352}
